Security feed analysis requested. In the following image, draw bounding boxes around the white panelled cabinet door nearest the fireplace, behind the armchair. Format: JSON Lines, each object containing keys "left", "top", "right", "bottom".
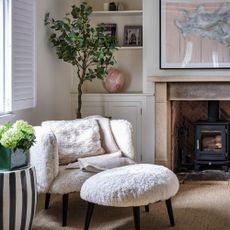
{"left": 105, "top": 101, "right": 142, "bottom": 162}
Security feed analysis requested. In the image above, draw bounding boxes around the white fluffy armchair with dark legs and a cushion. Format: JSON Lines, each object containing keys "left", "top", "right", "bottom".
{"left": 30, "top": 118, "right": 134, "bottom": 226}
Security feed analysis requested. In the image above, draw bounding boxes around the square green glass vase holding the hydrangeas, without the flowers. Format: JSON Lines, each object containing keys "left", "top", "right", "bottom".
{"left": 0, "top": 146, "right": 29, "bottom": 170}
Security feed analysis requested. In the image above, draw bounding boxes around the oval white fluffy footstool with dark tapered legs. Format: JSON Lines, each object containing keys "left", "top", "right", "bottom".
{"left": 80, "top": 164, "right": 179, "bottom": 230}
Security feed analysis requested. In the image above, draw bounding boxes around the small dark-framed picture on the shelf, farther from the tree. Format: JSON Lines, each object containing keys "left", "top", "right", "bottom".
{"left": 123, "top": 25, "right": 142, "bottom": 46}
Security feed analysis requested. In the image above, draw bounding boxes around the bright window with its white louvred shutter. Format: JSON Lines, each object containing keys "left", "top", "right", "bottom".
{"left": 0, "top": 0, "right": 36, "bottom": 114}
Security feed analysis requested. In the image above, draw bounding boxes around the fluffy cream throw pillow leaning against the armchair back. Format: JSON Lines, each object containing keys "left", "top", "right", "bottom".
{"left": 42, "top": 119, "right": 105, "bottom": 164}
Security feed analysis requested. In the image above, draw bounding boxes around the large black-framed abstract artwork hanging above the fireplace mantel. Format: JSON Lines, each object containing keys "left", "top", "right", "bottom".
{"left": 160, "top": 0, "right": 230, "bottom": 69}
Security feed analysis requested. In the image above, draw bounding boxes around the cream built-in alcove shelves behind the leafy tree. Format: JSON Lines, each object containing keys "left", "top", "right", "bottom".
{"left": 84, "top": 0, "right": 143, "bottom": 94}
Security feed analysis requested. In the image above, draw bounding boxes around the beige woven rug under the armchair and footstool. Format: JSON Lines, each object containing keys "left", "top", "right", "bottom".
{"left": 32, "top": 184, "right": 230, "bottom": 230}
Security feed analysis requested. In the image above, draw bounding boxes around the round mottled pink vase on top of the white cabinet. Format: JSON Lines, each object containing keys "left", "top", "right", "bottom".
{"left": 103, "top": 68, "right": 125, "bottom": 93}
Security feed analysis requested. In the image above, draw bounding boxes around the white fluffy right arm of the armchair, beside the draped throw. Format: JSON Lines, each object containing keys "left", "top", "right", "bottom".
{"left": 110, "top": 120, "right": 135, "bottom": 159}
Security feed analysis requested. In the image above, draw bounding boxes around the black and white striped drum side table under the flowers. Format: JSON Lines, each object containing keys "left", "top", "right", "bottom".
{"left": 0, "top": 167, "right": 37, "bottom": 230}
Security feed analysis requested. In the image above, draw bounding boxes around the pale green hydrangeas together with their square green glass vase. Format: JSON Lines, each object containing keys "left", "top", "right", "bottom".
{"left": 0, "top": 120, "right": 35, "bottom": 170}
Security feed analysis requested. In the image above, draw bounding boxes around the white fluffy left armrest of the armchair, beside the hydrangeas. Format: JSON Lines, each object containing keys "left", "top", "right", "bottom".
{"left": 30, "top": 126, "right": 59, "bottom": 193}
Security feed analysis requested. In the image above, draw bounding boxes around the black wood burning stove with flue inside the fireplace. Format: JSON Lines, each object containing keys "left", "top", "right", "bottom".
{"left": 195, "top": 101, "right": 230, "bottom": 171}
